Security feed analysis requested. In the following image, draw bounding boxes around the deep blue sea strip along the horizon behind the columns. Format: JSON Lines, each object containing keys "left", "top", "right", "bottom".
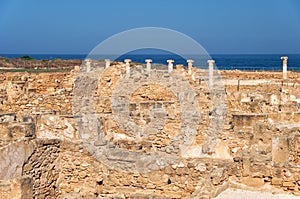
{"left": 0, "top": 54, "right": 300, "bottom": 71}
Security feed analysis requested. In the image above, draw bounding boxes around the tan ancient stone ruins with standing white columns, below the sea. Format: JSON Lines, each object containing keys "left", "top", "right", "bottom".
{"left": 0, "top": 57, "right": 300, "bottom": 199}
